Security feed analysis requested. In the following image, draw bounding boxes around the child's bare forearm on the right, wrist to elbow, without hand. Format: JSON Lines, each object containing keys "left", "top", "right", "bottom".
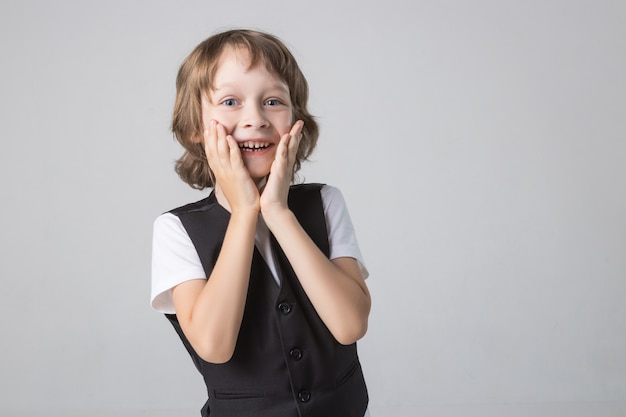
{"left": 265, "top": 209, "right": 371, "bottom": 344}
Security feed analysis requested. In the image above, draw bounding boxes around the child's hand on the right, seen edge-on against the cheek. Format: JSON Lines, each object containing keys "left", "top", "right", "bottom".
{"left": 260, "top": 120, "right": 304, "bottom": 220}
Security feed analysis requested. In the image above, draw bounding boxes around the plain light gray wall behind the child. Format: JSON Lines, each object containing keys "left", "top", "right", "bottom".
{"left": 0, "top": 0, "right": 626, "bottom": 417}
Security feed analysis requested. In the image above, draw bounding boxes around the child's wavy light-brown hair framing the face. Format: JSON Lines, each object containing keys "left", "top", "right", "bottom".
{"left": 172, "top": 29, "right": 319, "bottom": 190}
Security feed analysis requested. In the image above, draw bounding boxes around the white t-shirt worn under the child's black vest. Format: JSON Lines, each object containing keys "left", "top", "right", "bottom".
{"left": 150, "top": 185, "right": 369, "bottom": 314}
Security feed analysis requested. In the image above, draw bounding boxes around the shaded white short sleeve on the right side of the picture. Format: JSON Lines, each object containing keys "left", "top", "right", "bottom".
{"left": 321, "top": 185, "right": 369, "bottom": 278}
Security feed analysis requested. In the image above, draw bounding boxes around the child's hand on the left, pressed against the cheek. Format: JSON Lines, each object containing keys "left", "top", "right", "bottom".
{"left": 204, "top": 120, "right": 260, "bottom": 212}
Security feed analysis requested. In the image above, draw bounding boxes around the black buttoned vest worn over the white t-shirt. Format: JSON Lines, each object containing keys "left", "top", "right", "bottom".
{"left": 166, "top": 184, "right": 368, "bottom": 417}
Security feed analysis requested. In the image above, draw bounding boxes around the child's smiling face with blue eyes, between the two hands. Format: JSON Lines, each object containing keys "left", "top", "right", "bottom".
{"left": 202, "top": 48, "right": 293, "bottom": 181}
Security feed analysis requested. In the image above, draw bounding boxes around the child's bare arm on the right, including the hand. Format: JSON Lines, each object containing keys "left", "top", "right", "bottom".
{"left": 260, "top": 123, "right": 371, "bottom": 345}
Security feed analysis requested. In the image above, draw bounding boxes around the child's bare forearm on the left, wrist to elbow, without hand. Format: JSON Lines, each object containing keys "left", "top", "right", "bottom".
{"left": 174, "top": 211, "right": 258, "bottom": 363}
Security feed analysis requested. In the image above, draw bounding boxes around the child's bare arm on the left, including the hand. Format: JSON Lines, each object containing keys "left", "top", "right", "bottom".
{"left": 172, "top": 119, "right": 259, "bottom": 363}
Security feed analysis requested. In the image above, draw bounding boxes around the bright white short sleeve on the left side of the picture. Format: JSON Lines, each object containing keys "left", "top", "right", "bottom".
{"left": 150, "top": 213, "right": 206, "bottom": 314}
